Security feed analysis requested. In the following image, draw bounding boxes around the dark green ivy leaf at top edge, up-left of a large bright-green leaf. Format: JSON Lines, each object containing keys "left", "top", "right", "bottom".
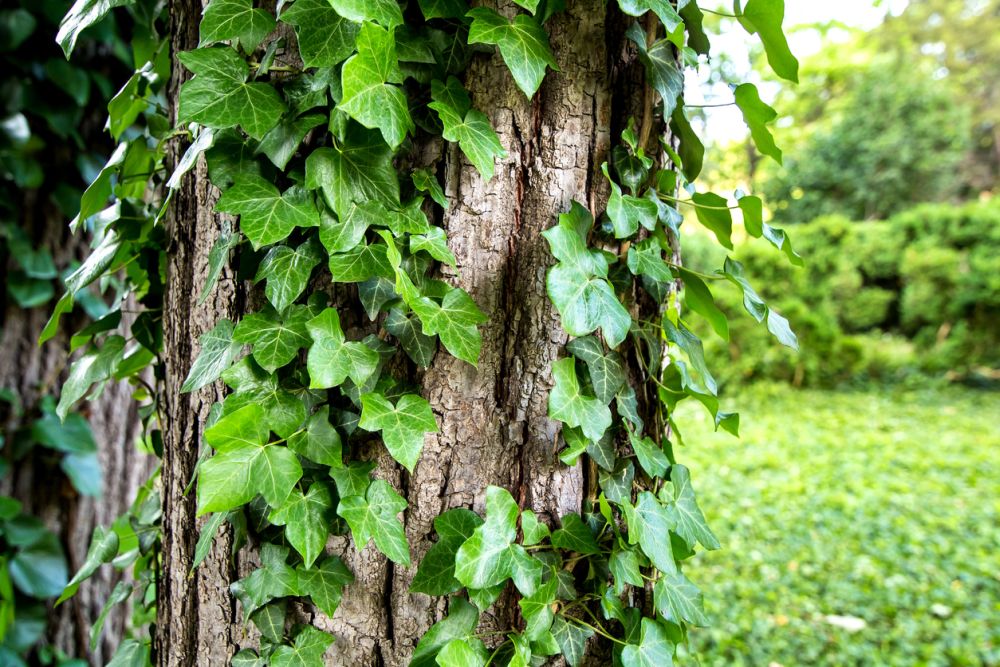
{"left": 280, "top": 0, "right": 360, "bottom": 67}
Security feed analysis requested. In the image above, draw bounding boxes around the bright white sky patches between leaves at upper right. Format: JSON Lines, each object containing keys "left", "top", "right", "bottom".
{"left": 684, "top": 0, "right": 907, "bottom": 143}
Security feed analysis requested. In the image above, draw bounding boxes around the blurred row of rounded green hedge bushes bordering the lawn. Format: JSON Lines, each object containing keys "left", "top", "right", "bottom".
{"left": 685, "top": 201, "right": 1000, "bottom": 385}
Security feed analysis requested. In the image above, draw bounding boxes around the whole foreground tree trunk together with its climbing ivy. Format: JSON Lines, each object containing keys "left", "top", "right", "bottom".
{"left": 52, "top": 0, "right": 798, "bottom": 665}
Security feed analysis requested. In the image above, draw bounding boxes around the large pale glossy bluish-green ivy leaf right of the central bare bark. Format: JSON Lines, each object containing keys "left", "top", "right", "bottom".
{"left": 542, "top": 202, "right": 632, "bottom": 347}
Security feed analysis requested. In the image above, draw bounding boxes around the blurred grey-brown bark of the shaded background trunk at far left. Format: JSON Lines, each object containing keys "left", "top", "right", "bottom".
{"left": 0, "top": 200, "right": 151, "bottom": 665}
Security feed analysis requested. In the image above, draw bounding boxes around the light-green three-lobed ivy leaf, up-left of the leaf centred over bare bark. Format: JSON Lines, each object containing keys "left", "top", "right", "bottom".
{"left": 306, "top": 308, "right": 378, "bottom": 389}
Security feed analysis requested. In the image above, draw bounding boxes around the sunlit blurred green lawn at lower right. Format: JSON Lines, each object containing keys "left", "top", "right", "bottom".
{"left": 677, "top": 386, "right": 1000, "bottom": 667}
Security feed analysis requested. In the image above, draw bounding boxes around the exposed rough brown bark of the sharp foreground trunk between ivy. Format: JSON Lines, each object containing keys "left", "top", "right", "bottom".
{"left": 156, "top": 0, "right": 656, "bottom": 667}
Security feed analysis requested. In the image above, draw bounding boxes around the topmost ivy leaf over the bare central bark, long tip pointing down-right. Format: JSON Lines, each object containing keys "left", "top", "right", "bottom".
{"left": 466, "top": 7, "right": 559, "bottom": 97}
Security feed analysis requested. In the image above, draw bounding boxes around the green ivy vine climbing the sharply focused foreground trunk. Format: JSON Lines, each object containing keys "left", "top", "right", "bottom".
{"left": 53, "top": 0, "right": 799, "bottom": 667}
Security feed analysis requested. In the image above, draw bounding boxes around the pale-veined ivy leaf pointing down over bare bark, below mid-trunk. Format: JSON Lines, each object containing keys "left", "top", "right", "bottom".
{"left": 358, "top": 394, "right": 438, "bottom": 473}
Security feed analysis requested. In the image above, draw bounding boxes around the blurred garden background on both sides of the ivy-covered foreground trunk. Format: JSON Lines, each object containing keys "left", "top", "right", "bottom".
{"left": 0, "top": 0, "right": 1000, "bottom": 667}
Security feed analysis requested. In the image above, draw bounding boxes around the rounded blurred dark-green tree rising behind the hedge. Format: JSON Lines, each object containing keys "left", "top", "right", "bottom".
{"left": 763, "top": 57, "right": 970, "bottom": 222}
